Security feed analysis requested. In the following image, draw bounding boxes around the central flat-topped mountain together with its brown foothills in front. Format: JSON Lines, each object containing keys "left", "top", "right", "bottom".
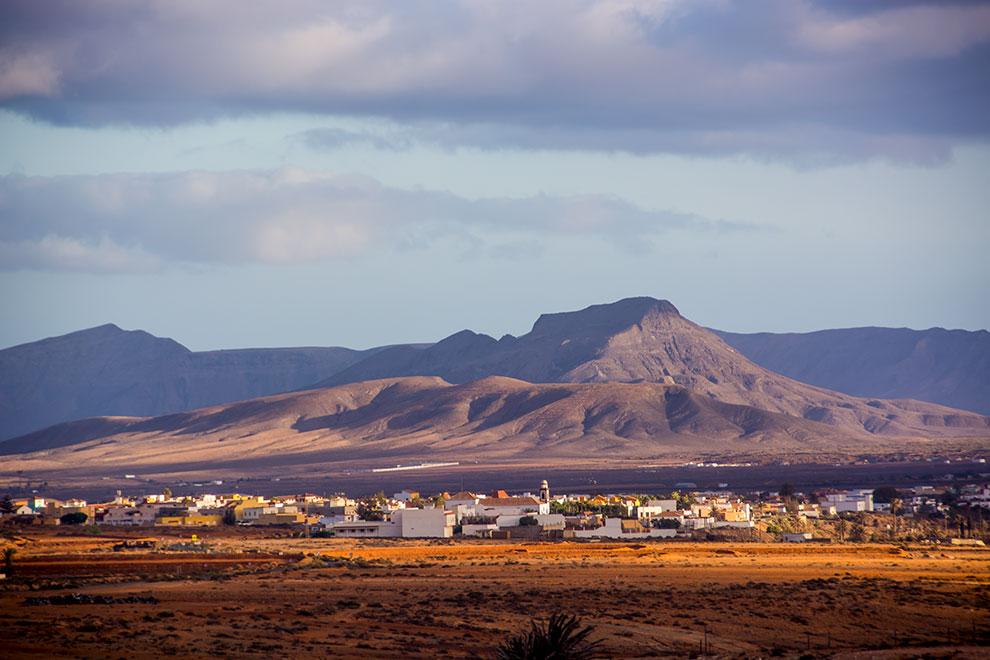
{"left": 0, "top": 298, "right": 990, "bottom": 471}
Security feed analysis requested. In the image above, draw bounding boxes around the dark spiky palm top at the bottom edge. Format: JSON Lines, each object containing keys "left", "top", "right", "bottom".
{"left": 495, "top": 614, "right": 601, "bottom": 660}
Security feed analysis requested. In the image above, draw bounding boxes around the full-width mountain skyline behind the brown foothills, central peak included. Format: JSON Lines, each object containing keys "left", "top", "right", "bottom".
{"left": 0, "top": 297, "right": 990, "bottom": 448}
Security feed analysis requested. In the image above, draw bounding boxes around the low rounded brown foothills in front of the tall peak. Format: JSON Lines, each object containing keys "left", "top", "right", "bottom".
{"left": 0, "top": 377, "right": 990, "bottom": 473}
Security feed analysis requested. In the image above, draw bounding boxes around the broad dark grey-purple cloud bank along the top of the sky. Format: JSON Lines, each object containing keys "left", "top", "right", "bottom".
{"left": 0, "top": 0, "right": 990, "bottom": 162}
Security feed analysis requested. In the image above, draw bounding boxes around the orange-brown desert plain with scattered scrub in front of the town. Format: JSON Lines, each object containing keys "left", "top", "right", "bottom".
{"left": 0, "top": 529, "right": 990, "bottom": 658}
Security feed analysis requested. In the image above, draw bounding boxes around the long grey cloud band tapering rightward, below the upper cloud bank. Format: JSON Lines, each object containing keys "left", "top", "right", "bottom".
{"left": 0, "top": 169, "right": 755, "bottom": 272}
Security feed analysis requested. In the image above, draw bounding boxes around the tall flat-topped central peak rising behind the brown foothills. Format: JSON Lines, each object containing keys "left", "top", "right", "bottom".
{"left": 312, "top": 298, "right": 983, "bottom": 435}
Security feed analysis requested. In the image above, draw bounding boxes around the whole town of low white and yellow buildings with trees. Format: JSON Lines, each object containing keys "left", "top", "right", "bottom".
{"left": 0, "top": 480, "right": 990, "bottom": 544}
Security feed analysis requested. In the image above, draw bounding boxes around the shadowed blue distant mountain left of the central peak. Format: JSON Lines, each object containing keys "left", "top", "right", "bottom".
{"left": 0, "top": 325, "right": 380, "bottom": 438}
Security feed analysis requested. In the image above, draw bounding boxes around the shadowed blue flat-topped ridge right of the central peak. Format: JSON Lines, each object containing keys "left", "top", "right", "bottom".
{"left": 715, "top": 328, "right": 990, "bottom": 414}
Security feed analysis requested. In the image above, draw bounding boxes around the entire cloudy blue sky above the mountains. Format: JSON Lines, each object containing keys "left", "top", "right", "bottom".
{"left": 0, "top": 0, "right": 990, "bottom": 350}
